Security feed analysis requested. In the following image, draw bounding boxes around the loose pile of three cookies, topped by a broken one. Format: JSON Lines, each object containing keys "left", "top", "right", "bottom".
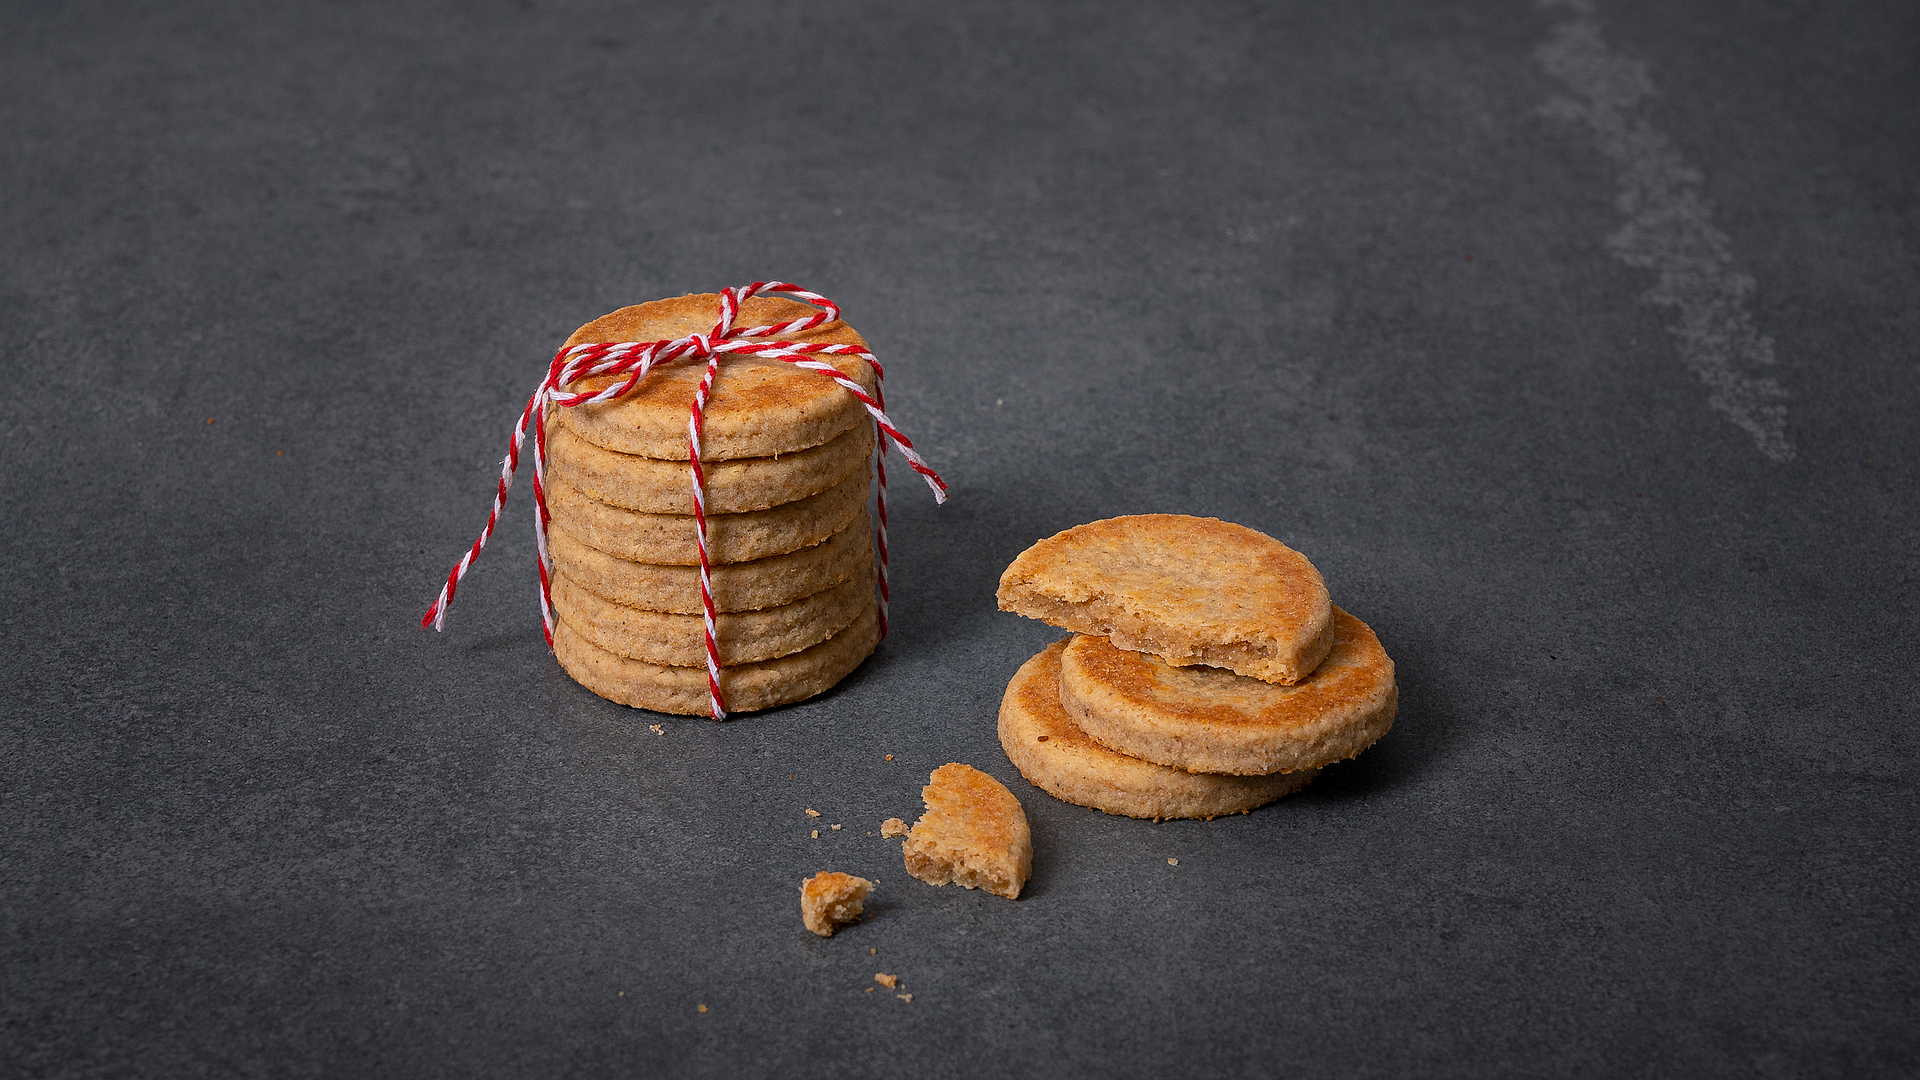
{"left": 998, "top": 513, "right": 1400, "bottom": 819}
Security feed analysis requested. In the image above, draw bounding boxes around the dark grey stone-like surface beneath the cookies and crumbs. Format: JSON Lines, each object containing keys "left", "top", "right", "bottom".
{"left": 0, "top": 0, "right": 1920, "bottom": 1076}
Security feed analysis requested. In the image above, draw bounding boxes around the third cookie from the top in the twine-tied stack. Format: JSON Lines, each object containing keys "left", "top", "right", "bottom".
{"left": 547, "top": 469, "right": 870, "bottom": 567}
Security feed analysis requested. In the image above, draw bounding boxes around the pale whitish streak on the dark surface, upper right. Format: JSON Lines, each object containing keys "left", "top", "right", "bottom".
{"left": 1534, "top": 0, "right": 1793, "bottom": 461}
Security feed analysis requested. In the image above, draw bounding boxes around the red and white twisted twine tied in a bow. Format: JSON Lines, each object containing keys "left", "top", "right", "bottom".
{"left": 420, "top": 281, "right": 947, "bottom": 721}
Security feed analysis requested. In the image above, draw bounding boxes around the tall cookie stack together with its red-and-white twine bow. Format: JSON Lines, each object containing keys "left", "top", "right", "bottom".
{"left": 422, "top": 282, "right": 947, "bottom": 719}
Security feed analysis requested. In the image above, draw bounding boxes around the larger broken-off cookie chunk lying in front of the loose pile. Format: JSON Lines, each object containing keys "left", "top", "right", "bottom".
{"left": 900, "top": 761, "right": 1033, "bottom": 899}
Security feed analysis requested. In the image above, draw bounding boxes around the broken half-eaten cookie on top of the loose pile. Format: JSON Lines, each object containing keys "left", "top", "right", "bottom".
{"left": 996, "top": 513, "right": 1332, "bottom": 684}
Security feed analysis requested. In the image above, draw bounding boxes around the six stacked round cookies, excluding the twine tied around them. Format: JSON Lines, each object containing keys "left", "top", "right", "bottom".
{"left": 547, "top": 294, "right": 879, "bottom": 715}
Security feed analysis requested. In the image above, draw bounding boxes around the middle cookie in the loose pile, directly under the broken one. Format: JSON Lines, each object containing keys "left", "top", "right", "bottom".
{"left": 1060, "top": 607, "right": 1400, "bottom": 776}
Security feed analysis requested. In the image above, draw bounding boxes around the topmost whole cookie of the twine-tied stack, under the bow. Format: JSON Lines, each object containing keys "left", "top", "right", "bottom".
{"left": 553, "top": 292, "right": 876, "bottom": 461}
